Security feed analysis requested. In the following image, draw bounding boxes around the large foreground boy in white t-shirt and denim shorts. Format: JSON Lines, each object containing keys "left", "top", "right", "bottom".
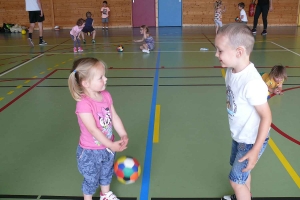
{"left": 215, "top": 23, "right": 272, "bottom": 200}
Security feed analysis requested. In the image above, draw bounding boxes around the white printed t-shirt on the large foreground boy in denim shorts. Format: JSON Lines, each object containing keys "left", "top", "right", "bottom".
{"left": 225, "top": 63, "right": 268, "bottom": 144}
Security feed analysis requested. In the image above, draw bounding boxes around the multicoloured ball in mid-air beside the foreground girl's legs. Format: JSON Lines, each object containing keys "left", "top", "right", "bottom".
{"left": 114, "top": 156, "right": 141, "bottom": 184}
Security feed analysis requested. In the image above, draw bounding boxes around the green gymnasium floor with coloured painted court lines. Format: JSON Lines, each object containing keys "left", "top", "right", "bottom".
{"left": 0, "top": 27, "right": 300, "bottom": 200}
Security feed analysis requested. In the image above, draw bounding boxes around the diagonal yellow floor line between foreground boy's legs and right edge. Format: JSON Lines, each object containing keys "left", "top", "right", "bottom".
{"left": 269, "top": 138, "right": 300, "bottom": 188}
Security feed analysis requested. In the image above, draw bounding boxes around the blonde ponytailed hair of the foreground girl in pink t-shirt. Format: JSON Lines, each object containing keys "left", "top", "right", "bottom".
{"left": 68, "top": 58, "right": 106, "bottom": 101}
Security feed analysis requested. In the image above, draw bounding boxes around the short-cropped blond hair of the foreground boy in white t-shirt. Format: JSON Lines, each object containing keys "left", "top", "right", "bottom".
{"left": 217, "top": 23, "right": 255, "bottom": 55}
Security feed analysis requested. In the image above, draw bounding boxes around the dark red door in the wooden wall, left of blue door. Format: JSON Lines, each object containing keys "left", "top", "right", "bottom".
{"left": 132, "top": 0, "right": 156, "bottom": 27}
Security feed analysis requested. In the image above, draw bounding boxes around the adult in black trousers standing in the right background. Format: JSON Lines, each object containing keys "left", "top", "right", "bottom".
{"left": 252, "top": 0, "right": 273, "bottom": 35}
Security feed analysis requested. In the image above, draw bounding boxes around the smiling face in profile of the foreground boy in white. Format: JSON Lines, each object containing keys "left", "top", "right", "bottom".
{"left": 215, "top": 35, "right": 237, "bottom": 68}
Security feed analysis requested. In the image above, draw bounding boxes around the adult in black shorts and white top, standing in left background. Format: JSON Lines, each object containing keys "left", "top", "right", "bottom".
{"left": 25, "top": 0, "right": 47, "bottom": 46}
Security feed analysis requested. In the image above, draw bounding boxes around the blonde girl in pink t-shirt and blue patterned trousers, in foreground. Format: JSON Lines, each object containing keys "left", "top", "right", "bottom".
{"left": 68, "top": 58, "right": 128, "bottom": 200}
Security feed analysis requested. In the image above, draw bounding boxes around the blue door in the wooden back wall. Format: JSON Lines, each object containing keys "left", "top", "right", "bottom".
{"left": 158, "top": 0, "right": 182, "bottom": 26}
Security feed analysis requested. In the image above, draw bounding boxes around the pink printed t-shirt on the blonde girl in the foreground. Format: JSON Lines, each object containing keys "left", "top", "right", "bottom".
{"left": 75, "top": 90, "right": 114, "bottom": 149}
